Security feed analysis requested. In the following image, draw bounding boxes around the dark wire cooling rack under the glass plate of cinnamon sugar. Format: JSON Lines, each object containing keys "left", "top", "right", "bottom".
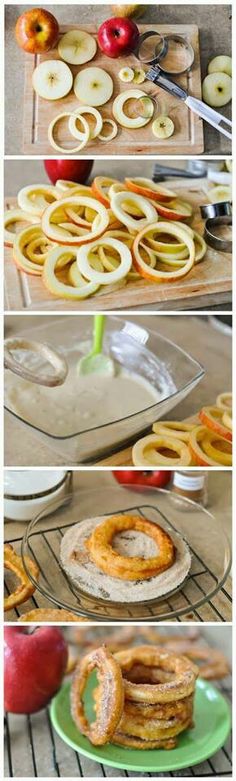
{"left": 5, "top": 505, "right": 232, "bottom": 622}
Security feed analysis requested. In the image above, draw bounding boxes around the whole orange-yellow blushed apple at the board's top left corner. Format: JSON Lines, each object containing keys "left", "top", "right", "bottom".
{"left": 15, "top": 8, "right": 59, "bottom": 54}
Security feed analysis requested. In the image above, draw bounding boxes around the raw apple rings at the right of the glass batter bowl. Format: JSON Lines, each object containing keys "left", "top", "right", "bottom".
{"left": 132, "top": 393, "right": 232, "bottom": 467}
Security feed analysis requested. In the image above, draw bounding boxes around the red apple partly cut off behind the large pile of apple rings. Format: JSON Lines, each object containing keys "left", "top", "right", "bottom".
{"left": 44, "top": 159, "right": 94, "bottom": 184}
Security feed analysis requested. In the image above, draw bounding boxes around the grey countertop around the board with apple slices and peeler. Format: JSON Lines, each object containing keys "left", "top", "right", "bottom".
{"left": 5, "top": 3, "right": 231, "bottom": 155}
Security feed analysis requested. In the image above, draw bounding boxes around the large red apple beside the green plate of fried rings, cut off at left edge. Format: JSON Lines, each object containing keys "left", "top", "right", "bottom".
{"left": 4, "top": 626, "right": 68, "bottom": 713}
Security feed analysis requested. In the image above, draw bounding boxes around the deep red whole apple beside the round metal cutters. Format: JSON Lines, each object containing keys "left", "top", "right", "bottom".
{"left": 98, "top": 16, "right": 139, "bottom": 57}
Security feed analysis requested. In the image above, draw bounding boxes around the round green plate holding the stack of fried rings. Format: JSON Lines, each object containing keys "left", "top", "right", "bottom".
{"left": 50, "top": 676, "right": 231, "bottom": 773}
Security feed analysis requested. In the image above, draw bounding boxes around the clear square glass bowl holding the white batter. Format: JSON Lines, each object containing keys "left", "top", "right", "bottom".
{"left": 5, "top": 315, "right": 204, "bottom": 465}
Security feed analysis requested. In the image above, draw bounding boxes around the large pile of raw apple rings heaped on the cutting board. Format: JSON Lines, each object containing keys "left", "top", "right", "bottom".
{"left": 4, "top": 175, "right": 206, "bottom": 301}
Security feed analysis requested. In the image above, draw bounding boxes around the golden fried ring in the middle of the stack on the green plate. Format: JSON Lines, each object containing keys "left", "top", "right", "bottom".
{"left": 124, "top": 694, "right": 193, "bottom": 721}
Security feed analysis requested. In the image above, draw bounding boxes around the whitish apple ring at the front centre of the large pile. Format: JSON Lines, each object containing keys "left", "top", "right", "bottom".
{"left": 77, "top": 237, "right": 132, "bottom": 285}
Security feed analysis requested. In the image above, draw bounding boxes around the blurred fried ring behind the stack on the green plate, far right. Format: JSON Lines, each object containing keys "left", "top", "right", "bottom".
{"left": 161, "top": 638, "right": 230, "bottom": 680}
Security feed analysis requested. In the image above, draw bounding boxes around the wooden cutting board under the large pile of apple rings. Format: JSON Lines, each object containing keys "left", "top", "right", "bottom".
{"left": 5, "top": 177, "right": 232, "bottom": 312}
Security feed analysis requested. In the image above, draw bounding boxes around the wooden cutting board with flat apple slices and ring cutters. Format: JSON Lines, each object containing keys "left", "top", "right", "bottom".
{"left": 22, "top": 24, "right": 204, "bottom": 157}
